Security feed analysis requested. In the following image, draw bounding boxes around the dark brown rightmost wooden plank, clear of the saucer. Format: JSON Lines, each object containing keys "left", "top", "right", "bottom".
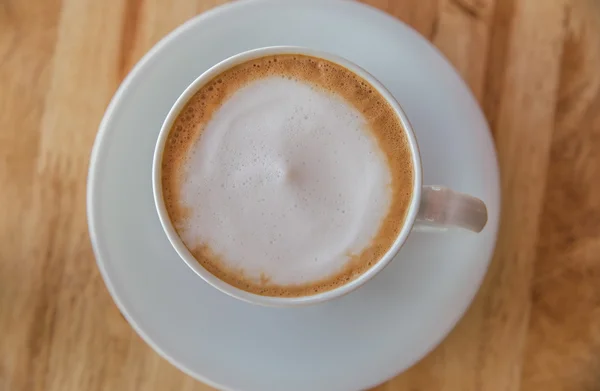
{"left": 522, "top": 0, "right": 600, "bottom": 391}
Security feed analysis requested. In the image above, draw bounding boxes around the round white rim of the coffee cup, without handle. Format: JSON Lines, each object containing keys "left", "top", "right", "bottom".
{"left": 152, "top": 46, "right": 423, "bottom": 307}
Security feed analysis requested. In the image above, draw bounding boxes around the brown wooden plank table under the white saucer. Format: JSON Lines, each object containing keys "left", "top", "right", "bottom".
{"left": 0, "top": 0, "right": 600, "bottom": 391}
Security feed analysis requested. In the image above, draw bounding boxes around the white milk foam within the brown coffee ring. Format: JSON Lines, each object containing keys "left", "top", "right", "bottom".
{"left": 178, "top": 76, "right": 392, "bottom": 285}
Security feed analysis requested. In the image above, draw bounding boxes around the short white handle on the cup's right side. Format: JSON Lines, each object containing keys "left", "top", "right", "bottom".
{"left": 414, "top": 186, "right": 487, "bottom": 232}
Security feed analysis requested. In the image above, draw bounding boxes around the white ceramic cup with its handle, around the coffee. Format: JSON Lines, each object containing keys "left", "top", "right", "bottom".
{"left": 152, "top": 46, "right": 487, "bottom": 307}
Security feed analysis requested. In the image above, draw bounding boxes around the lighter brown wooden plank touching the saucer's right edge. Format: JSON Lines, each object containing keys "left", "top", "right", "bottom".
{"left": 457, "top": 0, "right": 566, "bottom": 390}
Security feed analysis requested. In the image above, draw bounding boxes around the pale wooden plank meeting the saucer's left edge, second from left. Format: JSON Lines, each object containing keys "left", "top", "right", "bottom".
{"left": 15, "top": 1, "right": 131, "bottom": 390}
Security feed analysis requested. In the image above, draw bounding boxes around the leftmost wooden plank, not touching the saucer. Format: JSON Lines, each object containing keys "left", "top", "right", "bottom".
{"left": 0, "top": 1, "right": 68, "bottom": 390}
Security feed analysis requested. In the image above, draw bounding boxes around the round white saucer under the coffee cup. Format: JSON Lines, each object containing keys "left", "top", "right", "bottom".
{"left": 88, "top": 0, "right": 499, "bottom": 391}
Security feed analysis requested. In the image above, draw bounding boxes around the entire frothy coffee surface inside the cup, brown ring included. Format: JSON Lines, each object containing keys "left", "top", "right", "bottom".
{"left": 161, "top": 54, "right": 414, "bottom": 297}
